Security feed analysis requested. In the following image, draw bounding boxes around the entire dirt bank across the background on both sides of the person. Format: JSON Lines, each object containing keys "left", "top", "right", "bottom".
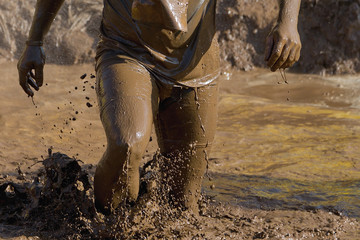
{"left": 0, "top": 0, "right": 360, "bottom": 74}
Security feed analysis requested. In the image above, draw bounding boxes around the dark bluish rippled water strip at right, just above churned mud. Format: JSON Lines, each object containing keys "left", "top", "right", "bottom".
{"left": 204, "top": 174, "right": 360, "bottom": 219}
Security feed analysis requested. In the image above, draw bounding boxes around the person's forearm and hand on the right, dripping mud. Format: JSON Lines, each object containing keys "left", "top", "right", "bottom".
{"left": 265, "top": 0, "right": 301, "bottom": 71}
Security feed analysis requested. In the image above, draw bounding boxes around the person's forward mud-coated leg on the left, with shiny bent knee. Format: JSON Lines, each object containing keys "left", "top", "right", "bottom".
{"left": 94, "top": 61, "right": 158, "bottom": 212}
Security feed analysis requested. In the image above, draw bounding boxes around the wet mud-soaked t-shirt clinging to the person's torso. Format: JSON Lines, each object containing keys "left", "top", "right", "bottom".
{"left": 99, "top": 0, "right": 219, "bottom": 87}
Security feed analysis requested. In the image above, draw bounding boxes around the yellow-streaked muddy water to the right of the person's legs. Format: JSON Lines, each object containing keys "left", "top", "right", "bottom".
{"left": 204, "top": 70, "right": 360, "bottom": 219}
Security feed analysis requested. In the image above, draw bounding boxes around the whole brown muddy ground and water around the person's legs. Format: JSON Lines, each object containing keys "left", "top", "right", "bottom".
{"left": 0, "top": 62, "right": 360, "bottom": 239}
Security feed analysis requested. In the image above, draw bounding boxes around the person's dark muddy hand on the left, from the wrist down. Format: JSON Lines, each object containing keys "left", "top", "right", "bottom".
{"left": 17, "top": 46, "right": 45, "bottom": 97}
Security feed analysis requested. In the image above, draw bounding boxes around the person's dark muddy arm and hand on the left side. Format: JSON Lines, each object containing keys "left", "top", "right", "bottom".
{"left": 17, "top": 0, "right": 64, "bottom": 96}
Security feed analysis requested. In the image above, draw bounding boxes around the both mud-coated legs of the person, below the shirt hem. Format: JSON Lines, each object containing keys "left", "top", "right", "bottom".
{"left": 94, "top": 52, "right": 218, "bottom": 212}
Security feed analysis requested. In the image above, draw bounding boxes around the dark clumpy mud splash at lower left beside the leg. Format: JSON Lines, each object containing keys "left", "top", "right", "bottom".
{"left": 0, "top": 153, "right": 96, "bottom": 237}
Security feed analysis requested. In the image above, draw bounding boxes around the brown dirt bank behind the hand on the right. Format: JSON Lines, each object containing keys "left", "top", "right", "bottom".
{"left": 217, "top": 0, "right": 360, "bottom": 74}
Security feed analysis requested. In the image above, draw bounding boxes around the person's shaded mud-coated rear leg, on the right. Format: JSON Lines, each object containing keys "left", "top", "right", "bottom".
{"left": 158, "top": 85, "right": 218, "bottom": 212}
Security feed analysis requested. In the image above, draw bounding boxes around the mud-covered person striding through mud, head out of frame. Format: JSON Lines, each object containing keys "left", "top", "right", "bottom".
{"left": 18, "top": 0, "right": 301, "bottom": 213}
